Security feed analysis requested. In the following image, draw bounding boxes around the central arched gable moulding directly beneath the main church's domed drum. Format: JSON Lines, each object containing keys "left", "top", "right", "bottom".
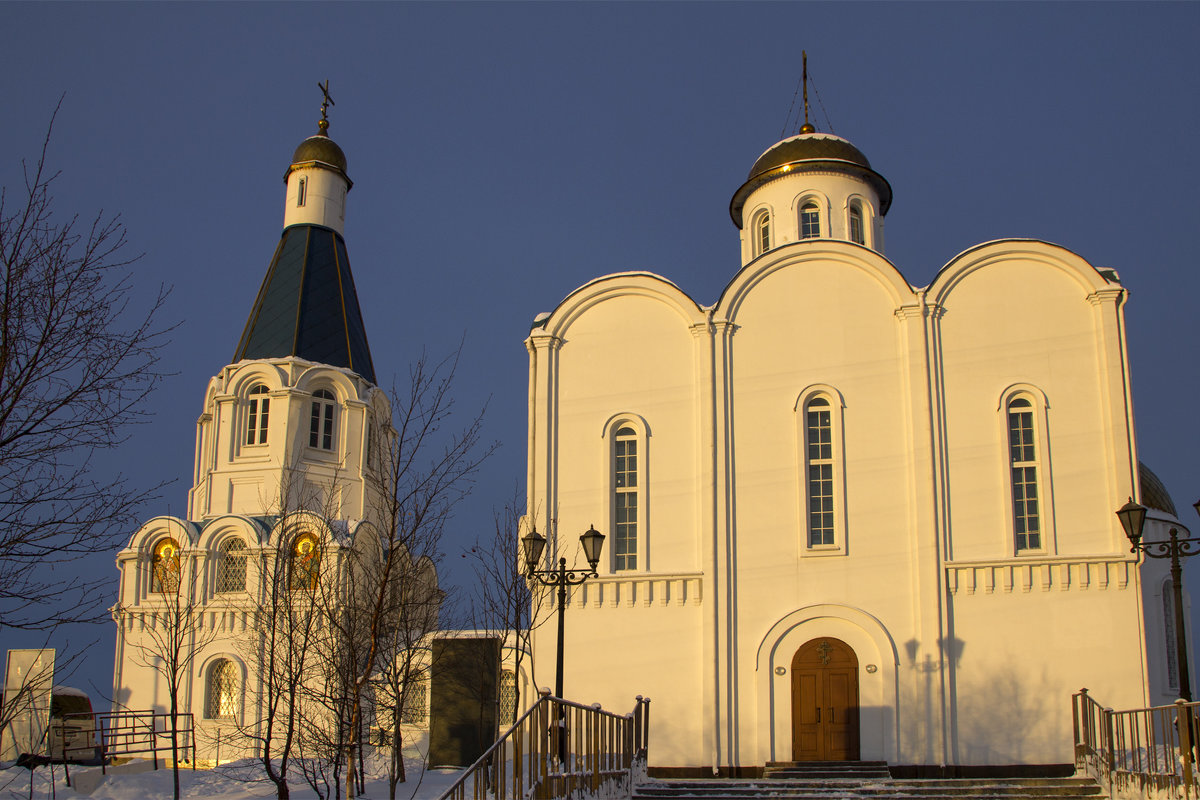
{"left": 714, "top": 239, "right": 916, "bottom": 321}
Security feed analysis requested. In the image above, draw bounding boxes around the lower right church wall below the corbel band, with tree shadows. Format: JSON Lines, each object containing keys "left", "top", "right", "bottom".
{"left": 950, "top": 573, "right": 1146, "bottom": 764}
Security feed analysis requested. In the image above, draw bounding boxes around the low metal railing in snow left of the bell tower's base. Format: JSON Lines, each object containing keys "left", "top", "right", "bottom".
{"left": 58, "top": 710, "right": 196, "bottom": 786}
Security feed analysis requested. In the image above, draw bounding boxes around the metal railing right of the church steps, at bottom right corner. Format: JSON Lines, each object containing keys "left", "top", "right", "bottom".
{"left": 1070, "top": 688, "right": 1200, "bottom": 798}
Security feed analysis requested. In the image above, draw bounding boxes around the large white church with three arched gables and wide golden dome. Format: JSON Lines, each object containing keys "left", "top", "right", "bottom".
{"left": 526, "top": 125, "right": 1183, "bottom": 775}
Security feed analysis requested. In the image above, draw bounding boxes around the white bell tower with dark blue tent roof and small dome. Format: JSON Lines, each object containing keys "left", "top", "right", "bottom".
{"left": 113, "top": 112, "right": 437, "bottom": 760}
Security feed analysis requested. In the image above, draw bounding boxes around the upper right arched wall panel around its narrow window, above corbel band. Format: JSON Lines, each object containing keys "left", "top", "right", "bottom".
{"left": 940, "top": 255, "right": 1123, "bottom": 560}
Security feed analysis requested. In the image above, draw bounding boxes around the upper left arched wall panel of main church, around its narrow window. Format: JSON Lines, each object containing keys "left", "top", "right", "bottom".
{"left": 549, "top": 295, "right": 700, "bottom": 573}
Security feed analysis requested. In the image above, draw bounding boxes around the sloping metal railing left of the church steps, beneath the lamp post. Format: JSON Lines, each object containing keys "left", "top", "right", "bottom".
{"left": 438, "top": 692, "right": 650, "bottom": 800}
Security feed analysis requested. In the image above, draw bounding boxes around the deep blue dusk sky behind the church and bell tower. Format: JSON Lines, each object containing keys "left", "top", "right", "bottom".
{"left": 0, "top": 2, "right": 1200, "bottom": 703}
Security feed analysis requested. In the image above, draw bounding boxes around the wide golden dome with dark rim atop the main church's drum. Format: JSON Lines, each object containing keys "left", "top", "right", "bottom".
{"left": 730, "top": 130, "right": 892, "bottom": 228}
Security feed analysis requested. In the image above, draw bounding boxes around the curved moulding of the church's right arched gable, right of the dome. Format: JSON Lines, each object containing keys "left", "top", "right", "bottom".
{"left": 926, "top": 239, "right": 1120, "bottom": 306}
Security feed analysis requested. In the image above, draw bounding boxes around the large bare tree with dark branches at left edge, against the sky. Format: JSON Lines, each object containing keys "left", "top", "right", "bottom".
{"left": 0, "top": 101, "right": 170, "bottom": 630}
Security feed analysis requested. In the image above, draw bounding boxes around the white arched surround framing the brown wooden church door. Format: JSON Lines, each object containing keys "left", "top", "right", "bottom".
{"left": 755, "top": 603, "right": 900, "bottom": 763}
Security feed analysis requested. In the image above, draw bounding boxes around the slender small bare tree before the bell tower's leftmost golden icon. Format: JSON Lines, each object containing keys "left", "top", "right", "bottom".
{"left": 114, "top": 540, "right": 217, "bottom": 800}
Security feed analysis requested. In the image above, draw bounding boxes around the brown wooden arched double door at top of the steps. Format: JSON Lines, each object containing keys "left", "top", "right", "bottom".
{"left": 792, "top": 637, "right": 858, "bottom": 762}
